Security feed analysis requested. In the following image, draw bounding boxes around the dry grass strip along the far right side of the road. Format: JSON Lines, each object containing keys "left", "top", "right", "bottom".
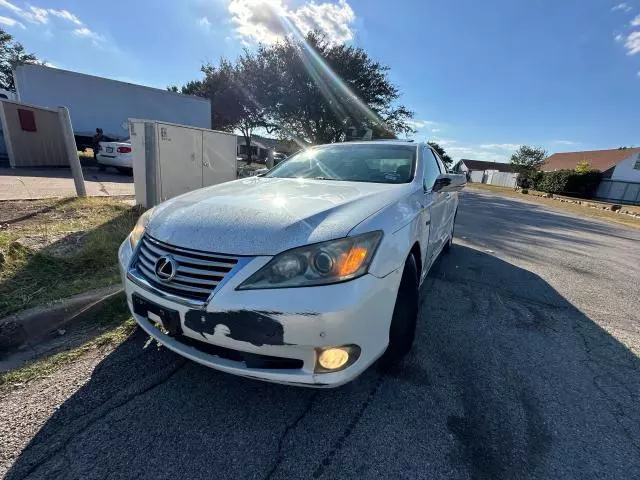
{"left": 468, "top": 183, "right": 640, "bottom": 229}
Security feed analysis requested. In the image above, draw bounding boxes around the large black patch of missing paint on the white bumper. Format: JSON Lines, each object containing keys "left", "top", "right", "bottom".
{"left": 184, "top": 310, "right": 285, "bottom": 347}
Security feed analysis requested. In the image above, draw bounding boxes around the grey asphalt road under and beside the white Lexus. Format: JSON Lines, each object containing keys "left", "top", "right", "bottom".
{"left": 7, "top": 192, "right": 640, "bottom": 479}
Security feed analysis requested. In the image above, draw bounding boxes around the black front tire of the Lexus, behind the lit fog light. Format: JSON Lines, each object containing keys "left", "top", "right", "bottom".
{"left": 377, "top": 254, "right": 419, "bottom": 372}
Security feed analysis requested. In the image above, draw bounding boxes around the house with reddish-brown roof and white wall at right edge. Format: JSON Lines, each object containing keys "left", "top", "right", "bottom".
{"left": 541, "top": 148, "right": 640, "bottom": 182}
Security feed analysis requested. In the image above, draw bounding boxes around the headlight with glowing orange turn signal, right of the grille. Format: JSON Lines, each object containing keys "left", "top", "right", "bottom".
{"left": 238, "top": 231, "right": 382, "bottom": 290}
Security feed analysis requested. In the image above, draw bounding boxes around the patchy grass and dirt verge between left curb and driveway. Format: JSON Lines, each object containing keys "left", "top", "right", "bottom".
{"left": 0, "top": 198, "right": 140, "bottom": 318}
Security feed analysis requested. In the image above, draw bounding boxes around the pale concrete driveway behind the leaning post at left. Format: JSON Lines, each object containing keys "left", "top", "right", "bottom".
{"left": 0, "top": 167, "right": 134, "bottom": 200}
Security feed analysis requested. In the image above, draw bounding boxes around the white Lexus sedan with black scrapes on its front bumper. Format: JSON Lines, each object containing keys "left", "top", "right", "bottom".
{"left": 119, "top": 141, "right": 466, "bottom": 387}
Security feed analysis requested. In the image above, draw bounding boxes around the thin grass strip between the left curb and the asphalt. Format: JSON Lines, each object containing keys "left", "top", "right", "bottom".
{"left": 0, "top": 297, "right": 136, "bottom": 392}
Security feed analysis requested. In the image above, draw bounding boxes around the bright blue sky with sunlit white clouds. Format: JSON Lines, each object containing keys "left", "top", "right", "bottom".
{"left": 0, "top": 0, "right": 640, "bottom": 161}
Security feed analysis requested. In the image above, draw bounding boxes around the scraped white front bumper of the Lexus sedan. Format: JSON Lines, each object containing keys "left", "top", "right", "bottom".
{"left": 118, "top": 239, "right": 402, "bottom": 387}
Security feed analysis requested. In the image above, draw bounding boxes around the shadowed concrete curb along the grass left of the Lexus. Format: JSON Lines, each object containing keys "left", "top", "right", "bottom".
{"left": 0, "top": 284, "right": 123, "bottom": 350}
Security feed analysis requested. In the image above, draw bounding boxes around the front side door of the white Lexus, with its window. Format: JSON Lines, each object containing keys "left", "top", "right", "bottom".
{"left": 423, "top": 148, "right": 447, "bottom": 271}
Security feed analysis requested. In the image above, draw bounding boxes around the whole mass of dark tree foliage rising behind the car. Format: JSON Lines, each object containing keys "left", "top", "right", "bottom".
{"left": 176, "top": 32, "right": 413, "bottom": 144}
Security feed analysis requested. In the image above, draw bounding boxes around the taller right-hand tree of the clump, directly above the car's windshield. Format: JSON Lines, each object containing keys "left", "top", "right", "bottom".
{"left": 257, "top": 32, "right": 414, "bottom": 144}
